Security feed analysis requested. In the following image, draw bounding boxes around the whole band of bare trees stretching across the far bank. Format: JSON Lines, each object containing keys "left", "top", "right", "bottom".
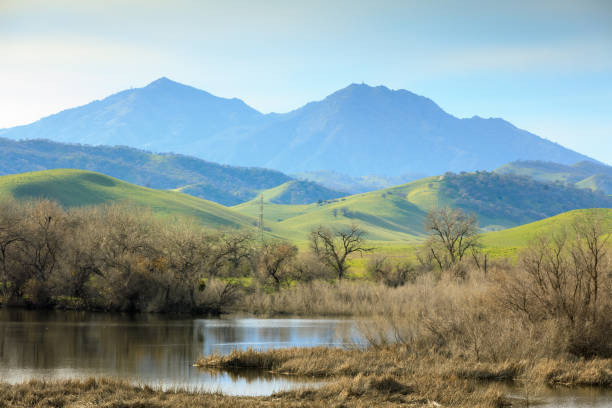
{"left": 0, "top": 200, "right": 612, "bottom": 356}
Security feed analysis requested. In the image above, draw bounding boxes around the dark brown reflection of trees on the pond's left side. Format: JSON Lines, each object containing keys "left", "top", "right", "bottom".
{"left": 0, "top": 310, "right": 202, "bottom": 375}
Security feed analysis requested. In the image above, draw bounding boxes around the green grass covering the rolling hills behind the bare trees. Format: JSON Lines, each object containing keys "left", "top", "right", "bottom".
{"left": 0, "top": 170, "right": 612, "bottom": 255}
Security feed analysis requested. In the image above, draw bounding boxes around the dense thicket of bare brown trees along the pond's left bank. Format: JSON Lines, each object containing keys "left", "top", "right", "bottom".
{"left": 0, "top": 201, "right": 256, "bottom": 312}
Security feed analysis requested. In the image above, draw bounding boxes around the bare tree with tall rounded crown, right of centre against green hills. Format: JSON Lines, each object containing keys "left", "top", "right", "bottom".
{"left": 424, "top": 207, "right": 479, "bottom": 269}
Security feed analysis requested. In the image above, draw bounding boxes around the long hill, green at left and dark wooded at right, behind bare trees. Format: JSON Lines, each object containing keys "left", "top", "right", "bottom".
{"left": 233, "top": 172, "right": 612, "bottom": 241}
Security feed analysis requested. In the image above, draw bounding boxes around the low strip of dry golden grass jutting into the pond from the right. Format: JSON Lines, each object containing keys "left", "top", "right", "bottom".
{"left": 196, "top": 345, "right": 612, "bottom": 388}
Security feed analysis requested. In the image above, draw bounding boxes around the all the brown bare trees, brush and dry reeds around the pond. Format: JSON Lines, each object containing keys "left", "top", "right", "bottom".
{"left": 0, "top": 201, "right": 612, "bottom": 406}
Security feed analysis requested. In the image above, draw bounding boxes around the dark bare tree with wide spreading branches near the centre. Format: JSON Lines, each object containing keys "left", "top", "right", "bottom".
{"left": 310, "top": 225, "right": 374, "bottom": 279}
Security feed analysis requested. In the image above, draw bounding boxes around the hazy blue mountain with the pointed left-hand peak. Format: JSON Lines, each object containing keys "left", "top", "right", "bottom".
{"left": 0, "top": 78, "right": 264, "bottom": 152}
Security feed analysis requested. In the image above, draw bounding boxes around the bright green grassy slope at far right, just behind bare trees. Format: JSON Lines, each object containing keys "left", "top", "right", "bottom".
{"left": 482, "top": 208, "right": 612, "bottom": 249}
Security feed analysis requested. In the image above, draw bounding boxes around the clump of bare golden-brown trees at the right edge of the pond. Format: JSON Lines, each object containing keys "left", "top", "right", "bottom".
{"left": 500, "top": 214, "right": 612, "bottom": 357}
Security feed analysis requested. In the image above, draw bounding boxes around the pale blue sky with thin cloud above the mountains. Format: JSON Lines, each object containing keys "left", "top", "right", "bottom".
{"left": 0, "top": 0, "right": 612, "bottom": 164}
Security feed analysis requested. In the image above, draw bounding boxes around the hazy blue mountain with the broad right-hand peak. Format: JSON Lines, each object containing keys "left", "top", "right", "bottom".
{"left": 235, "top": 84, "right": 587, "bottom": 175}
